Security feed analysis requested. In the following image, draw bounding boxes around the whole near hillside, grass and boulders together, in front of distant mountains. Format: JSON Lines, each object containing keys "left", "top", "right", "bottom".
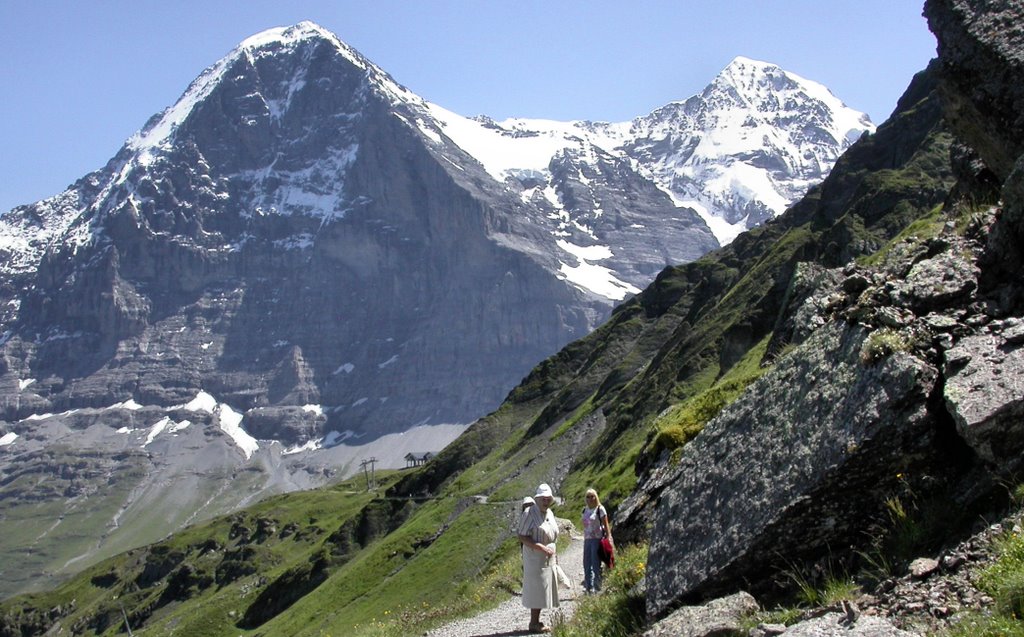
{"left": 0, "top": 0, "right": 1024, "bottom": 635}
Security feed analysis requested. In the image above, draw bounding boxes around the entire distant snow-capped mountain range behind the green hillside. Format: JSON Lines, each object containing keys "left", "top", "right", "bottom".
{"left": 0, "top": 23, "right": 872, "bottom": 592}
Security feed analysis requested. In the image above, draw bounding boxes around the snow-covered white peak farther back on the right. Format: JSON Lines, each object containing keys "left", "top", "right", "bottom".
{"left": 624, "top": 56, "right": 874, "bottom": 243}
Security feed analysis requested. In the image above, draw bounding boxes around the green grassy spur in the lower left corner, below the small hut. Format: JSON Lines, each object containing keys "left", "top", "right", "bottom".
{"left": 3, "top": 477, "right": 394, "bottom": 635}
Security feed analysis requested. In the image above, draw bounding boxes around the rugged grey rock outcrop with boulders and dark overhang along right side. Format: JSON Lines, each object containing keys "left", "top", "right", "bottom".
{"left": 647, "top": 1, "right": 1024, "bottom": 617}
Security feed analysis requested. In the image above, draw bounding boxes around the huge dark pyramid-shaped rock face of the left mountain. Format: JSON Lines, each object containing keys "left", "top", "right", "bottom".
{"left": 2, "top": 27, "right": 609, "bottom": 441}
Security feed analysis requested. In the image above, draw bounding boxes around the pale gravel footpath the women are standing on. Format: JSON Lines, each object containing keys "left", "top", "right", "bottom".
{"left": 425, "top": 534, "right": 583, "bottom": 637}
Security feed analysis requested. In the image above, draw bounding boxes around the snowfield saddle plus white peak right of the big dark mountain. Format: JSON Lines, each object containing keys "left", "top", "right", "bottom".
{"left": 411, "top": 56, "right": 874, "bottom": 248}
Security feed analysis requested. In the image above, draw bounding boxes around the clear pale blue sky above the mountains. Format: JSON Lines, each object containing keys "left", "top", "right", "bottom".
{"left": 0, "top": 0, "right": 935, "bottom": 211}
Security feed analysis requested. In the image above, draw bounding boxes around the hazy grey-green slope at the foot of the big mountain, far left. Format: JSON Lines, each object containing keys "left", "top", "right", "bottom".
{"left": 0, "top": 436, "right": 284, "bottom": 598}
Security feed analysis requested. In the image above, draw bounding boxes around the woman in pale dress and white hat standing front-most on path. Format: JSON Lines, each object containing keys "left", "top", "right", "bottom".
{"left": 517, "top": 484, "right": 558, "bottom": 633}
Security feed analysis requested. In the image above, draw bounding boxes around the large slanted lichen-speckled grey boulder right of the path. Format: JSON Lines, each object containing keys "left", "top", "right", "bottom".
{"left": 647, "top": 325, "right": 937, "bottom": 617}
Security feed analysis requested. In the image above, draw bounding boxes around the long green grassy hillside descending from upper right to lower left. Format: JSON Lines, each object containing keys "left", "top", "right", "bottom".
{"left": 0, "top": 66, "right": 966, "bottom": 636}
